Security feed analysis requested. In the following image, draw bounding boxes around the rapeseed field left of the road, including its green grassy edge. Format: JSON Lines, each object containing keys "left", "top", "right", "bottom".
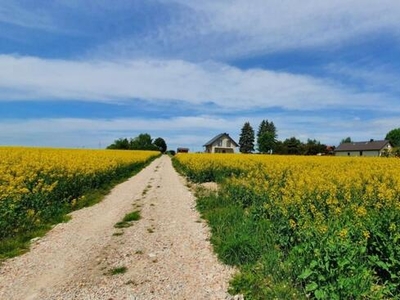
{"left": 0, "top": 147, "right": 160, "bottom": 259}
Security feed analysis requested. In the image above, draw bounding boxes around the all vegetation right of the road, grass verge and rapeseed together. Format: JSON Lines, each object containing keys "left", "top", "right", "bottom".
{"left": 174, "top": 154, "right": 400, "bottom": 299}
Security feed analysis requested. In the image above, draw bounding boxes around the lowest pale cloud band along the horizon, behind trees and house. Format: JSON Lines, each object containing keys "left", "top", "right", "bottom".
{"left": 0, "top": 113, "right": 398, "bottom": 151}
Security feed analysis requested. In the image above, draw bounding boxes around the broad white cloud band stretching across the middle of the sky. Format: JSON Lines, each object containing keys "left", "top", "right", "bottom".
{"left": 0, "top": 55, "right": 400, "bottom": 110}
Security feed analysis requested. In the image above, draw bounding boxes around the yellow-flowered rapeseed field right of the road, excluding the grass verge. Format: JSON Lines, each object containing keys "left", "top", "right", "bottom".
{"left": 175, "top": 154, "right": 400, "bottom": 299}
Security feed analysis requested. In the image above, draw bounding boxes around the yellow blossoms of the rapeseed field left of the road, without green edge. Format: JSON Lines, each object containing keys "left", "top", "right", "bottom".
{"left": 0, "top": 147, "right": 158, "bottom": 203}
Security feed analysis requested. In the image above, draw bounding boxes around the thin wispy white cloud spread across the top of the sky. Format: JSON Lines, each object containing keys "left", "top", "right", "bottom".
{"left": 0, "top": 0, "right": 400, "bottom": 60}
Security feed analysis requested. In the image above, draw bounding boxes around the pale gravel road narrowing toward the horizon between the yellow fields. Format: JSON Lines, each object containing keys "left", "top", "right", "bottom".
{"left": 0, "top": 155, "right": 238, "bottom": 300}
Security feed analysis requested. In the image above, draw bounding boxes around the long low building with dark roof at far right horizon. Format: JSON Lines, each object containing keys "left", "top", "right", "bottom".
{"left": 335, "top": 140, "right": 392, "bottom": 156}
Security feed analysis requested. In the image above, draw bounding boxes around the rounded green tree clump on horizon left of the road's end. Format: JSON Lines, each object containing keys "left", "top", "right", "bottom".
{"left": 107, "top": 133, "right": 167, "bottom": 153}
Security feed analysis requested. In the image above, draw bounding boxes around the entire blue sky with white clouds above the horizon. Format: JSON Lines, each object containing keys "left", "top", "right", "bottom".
{"left": 0, "top": 0, "right": 400, "bottom": 151}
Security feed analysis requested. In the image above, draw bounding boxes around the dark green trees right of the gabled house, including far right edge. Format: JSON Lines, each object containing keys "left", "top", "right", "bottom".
{"left": 239, "top": 120, "right": 400, "bottom": 155}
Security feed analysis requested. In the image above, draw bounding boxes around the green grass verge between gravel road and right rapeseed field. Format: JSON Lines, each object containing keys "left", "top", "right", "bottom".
{"left": 197, "top": 190, "right": 305, "bottom": 300}
